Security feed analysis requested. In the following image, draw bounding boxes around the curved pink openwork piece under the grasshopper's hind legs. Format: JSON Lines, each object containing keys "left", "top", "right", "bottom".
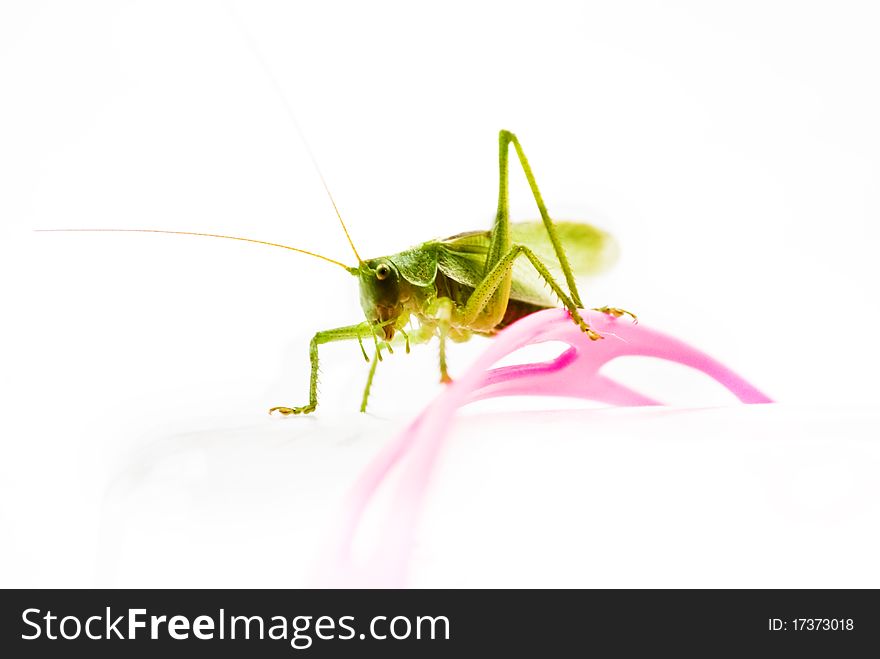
{"left": 318, "top": 309, "right": 772, "bottom": 587}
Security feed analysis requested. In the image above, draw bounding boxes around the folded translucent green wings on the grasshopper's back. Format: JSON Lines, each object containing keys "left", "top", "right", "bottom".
{"left": 437, "top": 222, "right": 617, "bottom": 306}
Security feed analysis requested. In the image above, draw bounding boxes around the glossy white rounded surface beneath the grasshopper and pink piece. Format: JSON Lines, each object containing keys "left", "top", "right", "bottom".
{"left": 98, "top": 405, "right": 880, "bottom": 588}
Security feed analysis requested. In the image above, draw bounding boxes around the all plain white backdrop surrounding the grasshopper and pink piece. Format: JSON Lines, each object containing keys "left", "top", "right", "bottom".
{"left": 0, "top": 2, "right": 880, "bottom": 587}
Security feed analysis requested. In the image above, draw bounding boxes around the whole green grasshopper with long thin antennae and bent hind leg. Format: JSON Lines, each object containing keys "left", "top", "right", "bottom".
{"left": 44, "top": 130, "right": 635, "bottom": 415}
